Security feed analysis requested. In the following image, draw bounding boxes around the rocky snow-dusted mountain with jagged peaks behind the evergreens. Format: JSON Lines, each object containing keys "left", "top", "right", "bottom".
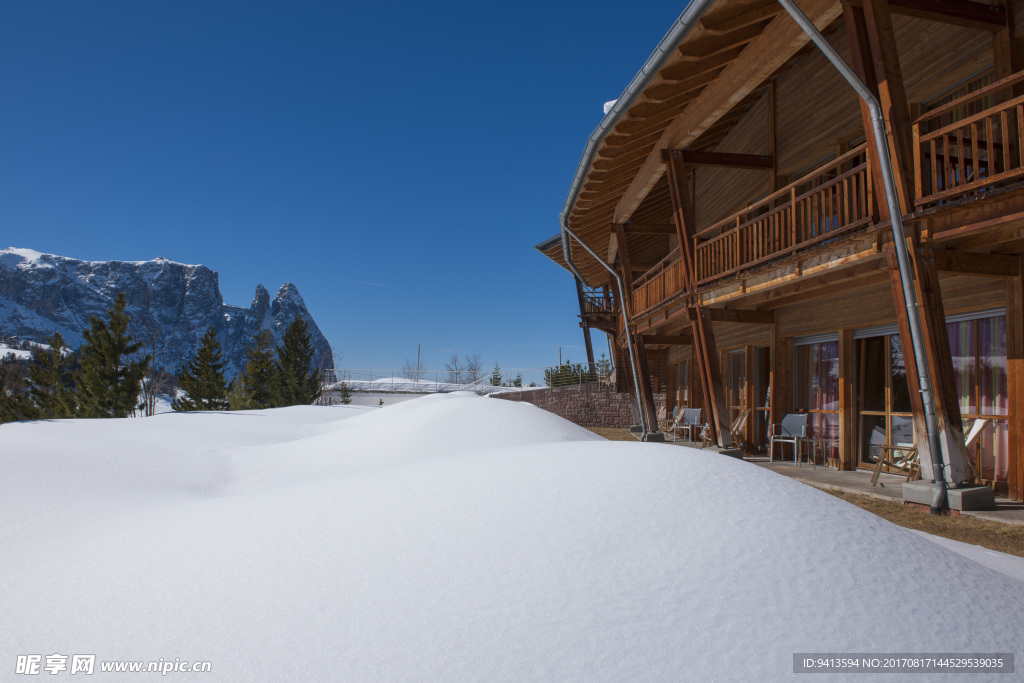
{"left": 0, "top": 248, "right": 334, "bottom": 376}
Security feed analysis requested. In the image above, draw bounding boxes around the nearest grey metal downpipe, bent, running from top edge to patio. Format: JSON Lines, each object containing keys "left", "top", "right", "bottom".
{"left": 778, "top": 0, "right": 946, "bottom": 515}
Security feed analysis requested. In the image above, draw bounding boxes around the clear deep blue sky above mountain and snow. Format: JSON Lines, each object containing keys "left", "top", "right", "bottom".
{"left": 0, "top": 0, "right": 686, "bottom": 369}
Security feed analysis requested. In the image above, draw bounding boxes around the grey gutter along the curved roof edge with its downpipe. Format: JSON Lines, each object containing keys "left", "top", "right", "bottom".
{"left": 558, "top": 0, "right": 714, "bottom": 440}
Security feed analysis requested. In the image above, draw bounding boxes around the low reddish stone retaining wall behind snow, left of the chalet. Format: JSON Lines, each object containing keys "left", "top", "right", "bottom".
{"left": 492, "top": 384, "right": 665, "bottom": 427}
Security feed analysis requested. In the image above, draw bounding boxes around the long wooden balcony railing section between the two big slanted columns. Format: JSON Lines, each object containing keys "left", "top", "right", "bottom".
{"left": 693, "top": 145, "right": 874, "bottom": 285}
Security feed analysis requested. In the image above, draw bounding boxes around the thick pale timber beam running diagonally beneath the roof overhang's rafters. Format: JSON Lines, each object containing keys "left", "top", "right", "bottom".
{"left": 613, "top": 0, "right": 842, "bottom": 223}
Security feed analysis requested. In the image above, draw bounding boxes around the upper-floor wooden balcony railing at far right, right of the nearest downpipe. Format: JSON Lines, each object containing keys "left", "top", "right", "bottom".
{"left": 913, "top": 72, "right": 1024, "bottom": 207}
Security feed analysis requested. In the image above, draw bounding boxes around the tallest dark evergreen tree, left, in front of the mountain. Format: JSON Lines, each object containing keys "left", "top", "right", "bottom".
{"left": 75, "top": 292, "right": 152, "bottom": 418}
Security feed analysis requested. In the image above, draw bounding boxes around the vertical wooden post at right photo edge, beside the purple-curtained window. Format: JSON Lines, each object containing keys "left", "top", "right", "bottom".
{"left": 1007, "top": 256, "right": 1024, "bottom": 501}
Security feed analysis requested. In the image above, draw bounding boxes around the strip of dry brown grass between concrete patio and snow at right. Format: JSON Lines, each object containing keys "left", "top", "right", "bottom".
{"left": 822, "top": 488, "right": 1024, "bottom": 557}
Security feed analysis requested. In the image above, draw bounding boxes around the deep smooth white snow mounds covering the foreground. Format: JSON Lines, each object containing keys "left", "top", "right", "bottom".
{"left": 0, "top": 394, "right": 1024, "bottom": 682}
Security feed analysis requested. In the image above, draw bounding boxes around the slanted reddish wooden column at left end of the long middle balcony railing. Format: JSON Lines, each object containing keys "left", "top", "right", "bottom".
{"left": 663, "top": 150, "right": 732, "bottom": 447}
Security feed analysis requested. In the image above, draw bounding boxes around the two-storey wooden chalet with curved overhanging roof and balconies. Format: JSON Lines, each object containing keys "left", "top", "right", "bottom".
{"left": 538, "top": 0, "right": 1024, "bottom": 500}
